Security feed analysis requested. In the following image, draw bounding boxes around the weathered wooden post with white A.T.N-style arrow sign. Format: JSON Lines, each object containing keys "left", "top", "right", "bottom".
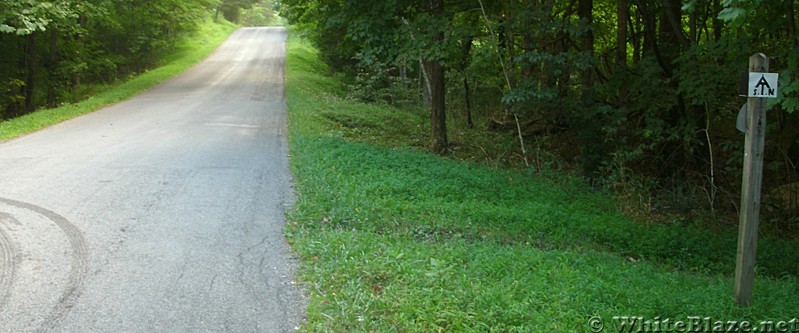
{"left": 735, "top": 53, "right": 777, "bottom": 306}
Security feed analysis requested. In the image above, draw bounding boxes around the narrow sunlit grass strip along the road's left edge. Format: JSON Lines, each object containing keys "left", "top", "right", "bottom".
{"left": 0, "top": 20, "right": 237, "bottom": 142}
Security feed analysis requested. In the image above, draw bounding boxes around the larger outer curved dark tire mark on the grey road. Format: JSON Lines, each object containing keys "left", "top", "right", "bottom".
{"left": 0, "top": 198, "right": 89, "bottom": 330}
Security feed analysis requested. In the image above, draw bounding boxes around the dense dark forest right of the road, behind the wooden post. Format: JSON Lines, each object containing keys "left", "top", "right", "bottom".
{"left": 280, "top": 0, "right": 799, "bottom": 226}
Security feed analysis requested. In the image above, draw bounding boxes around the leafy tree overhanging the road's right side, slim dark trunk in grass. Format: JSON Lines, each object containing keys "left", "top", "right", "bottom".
{"left": 282, "top": 0, "right": 456, "bottom": 155}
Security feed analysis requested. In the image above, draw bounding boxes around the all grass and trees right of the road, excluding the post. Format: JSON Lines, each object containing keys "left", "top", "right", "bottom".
{"left": 280, "top": 0, "right": 799, "bottom": 331}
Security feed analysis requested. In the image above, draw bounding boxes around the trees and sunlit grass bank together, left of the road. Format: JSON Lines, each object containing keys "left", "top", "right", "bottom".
{"left": 0, "top": 0, "right": 276, "bottom": 140}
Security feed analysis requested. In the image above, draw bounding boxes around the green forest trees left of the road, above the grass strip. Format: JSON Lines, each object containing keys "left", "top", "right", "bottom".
{"left": 0, "top": 0, "right": 272, "bottom": 120}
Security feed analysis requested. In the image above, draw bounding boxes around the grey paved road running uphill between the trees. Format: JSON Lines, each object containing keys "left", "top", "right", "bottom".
{"left": 0, "top": 28, "right": 304, "bottom": 332}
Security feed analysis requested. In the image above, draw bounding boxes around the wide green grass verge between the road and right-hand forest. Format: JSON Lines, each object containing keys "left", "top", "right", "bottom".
{"left": 286, "top": 30, "right": 799, "bottom": 332}
